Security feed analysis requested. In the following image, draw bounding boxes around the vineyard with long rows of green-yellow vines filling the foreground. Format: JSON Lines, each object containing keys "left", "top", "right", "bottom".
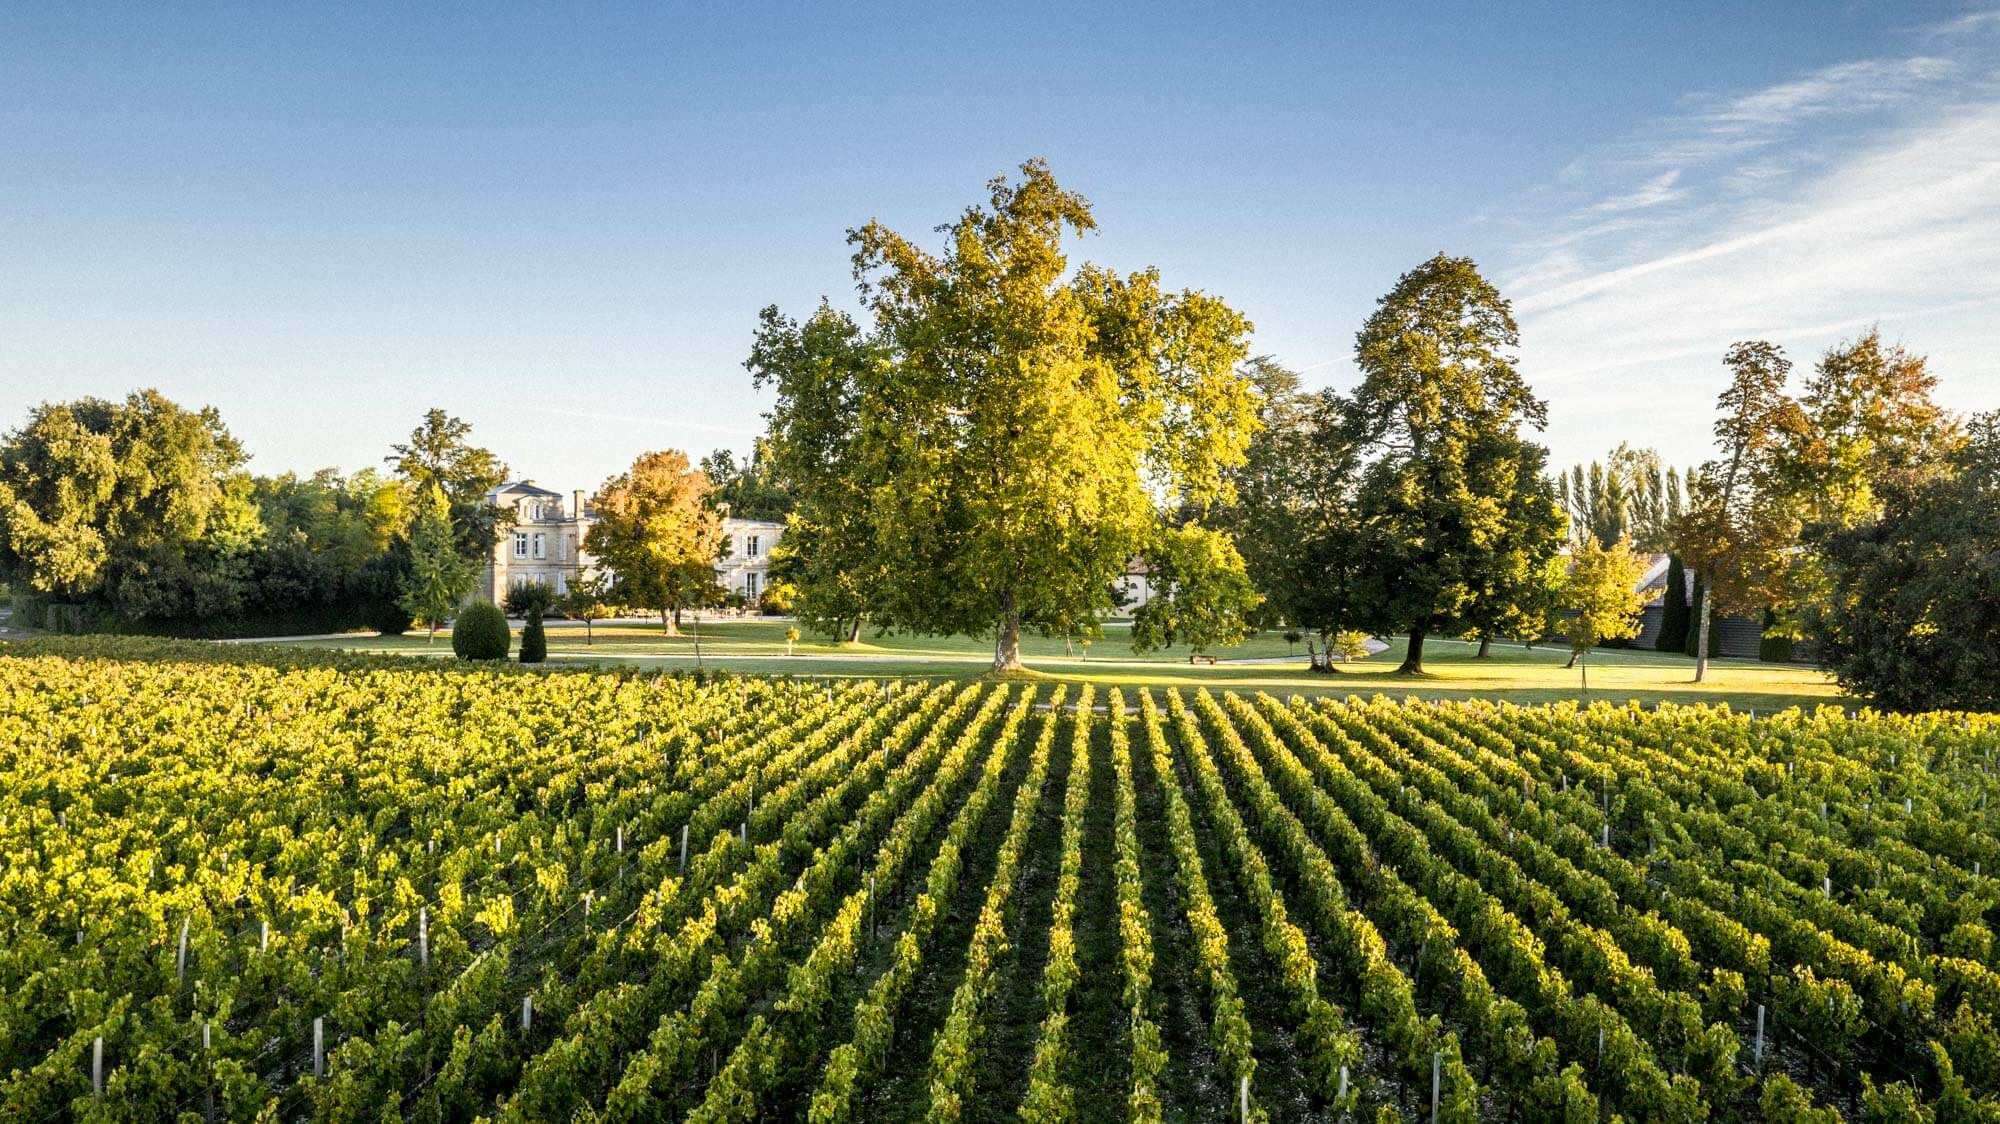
{"left": 0, "top": 644, "right": 2000, "bottom": 1124}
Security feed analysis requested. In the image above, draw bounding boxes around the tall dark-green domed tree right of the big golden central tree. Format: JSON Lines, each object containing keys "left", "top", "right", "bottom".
{"left": 1348, "top": 254, "right": 1562, "bottom": 672}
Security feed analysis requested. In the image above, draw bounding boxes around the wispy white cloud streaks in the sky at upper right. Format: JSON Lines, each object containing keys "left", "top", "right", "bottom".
{"left": 1502, "top": 10, "right": 2000, "bottom": 460}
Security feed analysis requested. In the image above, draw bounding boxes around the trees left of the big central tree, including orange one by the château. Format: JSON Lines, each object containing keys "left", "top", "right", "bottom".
{"left": 0, "top": 390, "right": 790, "bottom": 636}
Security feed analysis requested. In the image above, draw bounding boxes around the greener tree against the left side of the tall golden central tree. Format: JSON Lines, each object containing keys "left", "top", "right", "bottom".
{"left": 744, "top": 302, "right": 890, "bottom": 640}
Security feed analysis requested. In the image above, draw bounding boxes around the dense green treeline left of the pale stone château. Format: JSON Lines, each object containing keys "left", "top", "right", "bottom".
{"left": 0, "top": 398, "right": 506, "bottom": 636}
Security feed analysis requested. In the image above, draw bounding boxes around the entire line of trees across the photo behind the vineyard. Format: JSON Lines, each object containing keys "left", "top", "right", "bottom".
{"left": 0, "top": 162, "right": 1994, "bottom": 704}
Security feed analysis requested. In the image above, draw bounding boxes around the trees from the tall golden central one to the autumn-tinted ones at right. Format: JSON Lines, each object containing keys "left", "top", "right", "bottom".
{"left": 746, "top": 162, "right": 1988, "bottom": 698}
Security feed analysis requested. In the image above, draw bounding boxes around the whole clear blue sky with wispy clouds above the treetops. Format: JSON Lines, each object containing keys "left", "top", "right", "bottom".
{"left": 0, "top": 2, "right": 2000, "bottom": 488}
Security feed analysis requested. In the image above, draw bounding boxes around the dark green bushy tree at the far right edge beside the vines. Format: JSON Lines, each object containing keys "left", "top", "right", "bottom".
{"left": 1812, "top": 414, "right": 2000, "bottom": 710}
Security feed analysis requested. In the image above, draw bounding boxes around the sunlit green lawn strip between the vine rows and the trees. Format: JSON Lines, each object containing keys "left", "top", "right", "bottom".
{"left": 274, "top": 620, "right": 1850, "bottom": 710}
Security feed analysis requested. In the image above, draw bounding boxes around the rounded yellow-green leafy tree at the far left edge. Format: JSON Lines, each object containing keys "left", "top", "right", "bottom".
{"left": 0, "top": 390, "right": 264, "bottom": 620}
